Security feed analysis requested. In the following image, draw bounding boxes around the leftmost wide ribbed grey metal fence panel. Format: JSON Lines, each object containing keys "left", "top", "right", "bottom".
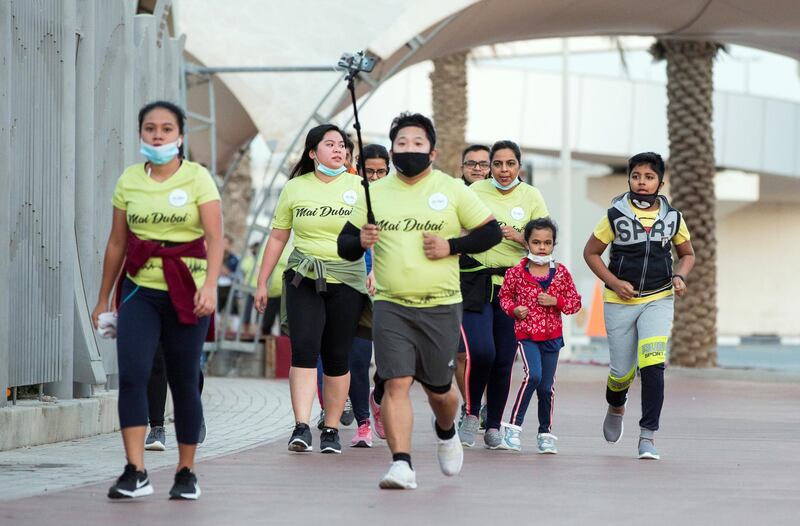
{"left": 7, "top": 0, "right": 76, "bottom": 385}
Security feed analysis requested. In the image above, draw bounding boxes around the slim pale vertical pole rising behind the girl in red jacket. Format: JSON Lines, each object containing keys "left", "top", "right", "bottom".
{"left": 559, "top": 38, "right": 572, "bottom": 359}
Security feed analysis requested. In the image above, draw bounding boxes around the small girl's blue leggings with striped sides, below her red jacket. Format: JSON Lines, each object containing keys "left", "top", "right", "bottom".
{"left": 511, "top": 340, "right": 558, "bottom": 433}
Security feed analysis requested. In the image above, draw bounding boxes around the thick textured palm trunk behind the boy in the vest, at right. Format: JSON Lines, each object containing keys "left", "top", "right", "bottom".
{"left": 650, "top": 40, "right": 722, "bottom": 367}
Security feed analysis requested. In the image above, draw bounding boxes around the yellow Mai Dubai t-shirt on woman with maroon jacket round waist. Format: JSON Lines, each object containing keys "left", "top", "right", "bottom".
{"left": 111, "top": 161, "right": 219, "bottom": 290}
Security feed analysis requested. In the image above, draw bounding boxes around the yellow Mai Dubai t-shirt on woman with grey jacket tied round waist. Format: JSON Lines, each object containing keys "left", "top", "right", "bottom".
{"left": 272, "top": 172, "right": 364, "bottom": 283}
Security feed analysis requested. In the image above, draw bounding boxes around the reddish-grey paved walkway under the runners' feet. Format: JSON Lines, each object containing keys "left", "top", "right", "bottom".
{"left": 0, "top": 365, "right": 800, "bottom": 526}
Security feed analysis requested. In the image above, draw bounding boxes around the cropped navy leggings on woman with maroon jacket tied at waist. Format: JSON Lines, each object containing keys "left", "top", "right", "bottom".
{"left": 117, "top": 279, "right": 210, "bottom": 444}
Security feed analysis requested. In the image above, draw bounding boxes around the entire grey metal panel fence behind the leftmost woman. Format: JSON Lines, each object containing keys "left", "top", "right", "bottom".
{"left": 0, "top": 0, "right": 184, "bottom": 398}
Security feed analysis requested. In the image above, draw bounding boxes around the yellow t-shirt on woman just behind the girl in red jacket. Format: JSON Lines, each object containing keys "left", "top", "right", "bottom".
{"left": 469, "top": 179, "right": 550, "bottom": 285}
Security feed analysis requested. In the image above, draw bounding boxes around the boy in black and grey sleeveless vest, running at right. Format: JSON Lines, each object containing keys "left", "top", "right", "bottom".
{"left": 583, "top": 152, "right": 694, "bottom": 460}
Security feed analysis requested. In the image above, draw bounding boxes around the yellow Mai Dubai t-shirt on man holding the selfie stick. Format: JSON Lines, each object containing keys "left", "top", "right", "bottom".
{"left": 350, "top": 170, "right": 491, "bottom": 307}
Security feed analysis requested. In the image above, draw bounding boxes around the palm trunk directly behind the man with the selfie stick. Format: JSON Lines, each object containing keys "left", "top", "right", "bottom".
{"left": 431, "top": 51, "right": 467, "bottom": 177}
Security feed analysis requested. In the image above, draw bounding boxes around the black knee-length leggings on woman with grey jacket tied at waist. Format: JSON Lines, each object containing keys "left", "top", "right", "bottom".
{"left": 284, "top": 270, "right": 364, "bottom": 376}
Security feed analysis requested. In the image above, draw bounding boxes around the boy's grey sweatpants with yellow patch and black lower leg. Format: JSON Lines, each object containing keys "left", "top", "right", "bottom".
{"left": 603, "top": 296, "right": 674, "bottom": 432}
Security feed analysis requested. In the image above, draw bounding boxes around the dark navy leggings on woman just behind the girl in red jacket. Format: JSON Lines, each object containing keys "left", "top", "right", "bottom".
{"left": 461, "top": 298, "right": 517, "bottom": 429}
